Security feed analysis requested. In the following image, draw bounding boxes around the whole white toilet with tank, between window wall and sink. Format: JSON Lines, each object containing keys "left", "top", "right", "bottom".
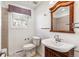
{"left": 23, "top": 36, "right": 41, "bottom": 57}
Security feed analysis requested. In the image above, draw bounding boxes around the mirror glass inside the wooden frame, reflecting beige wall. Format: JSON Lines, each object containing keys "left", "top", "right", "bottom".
{"left": 53, "top": 7, "right": 69, "bottom": 31}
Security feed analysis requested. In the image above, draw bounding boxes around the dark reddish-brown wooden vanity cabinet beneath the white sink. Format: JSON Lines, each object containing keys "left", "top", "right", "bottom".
{"left": 45, "top": 47, "right": 74, "bottom": 57}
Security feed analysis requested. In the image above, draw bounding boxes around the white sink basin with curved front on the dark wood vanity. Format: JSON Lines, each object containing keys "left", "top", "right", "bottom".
{"left": 42, "top": 39, "right": 75, "bottom": 52}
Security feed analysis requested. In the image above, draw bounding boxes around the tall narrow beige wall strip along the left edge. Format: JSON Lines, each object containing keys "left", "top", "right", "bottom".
{"left": 1, "top": 8, "right": 8, "bottom": 48}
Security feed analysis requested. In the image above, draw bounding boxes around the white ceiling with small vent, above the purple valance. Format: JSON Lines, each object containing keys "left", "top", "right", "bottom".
{"left": 2, "top": 1, "right": 44, "bottom": 8}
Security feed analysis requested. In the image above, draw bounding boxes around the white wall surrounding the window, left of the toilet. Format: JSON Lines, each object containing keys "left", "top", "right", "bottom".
{"left": 2, "top": 2, "right": 35, "bottom": 56}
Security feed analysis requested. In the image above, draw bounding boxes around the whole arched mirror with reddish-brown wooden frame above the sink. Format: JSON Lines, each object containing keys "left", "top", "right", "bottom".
{"left": 50, "top": 1, "right": 74, "bottom": 33}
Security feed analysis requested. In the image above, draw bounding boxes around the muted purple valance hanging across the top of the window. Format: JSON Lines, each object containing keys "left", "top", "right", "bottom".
{"left": 8, "top": 5, "right": 31, "bottom": 16}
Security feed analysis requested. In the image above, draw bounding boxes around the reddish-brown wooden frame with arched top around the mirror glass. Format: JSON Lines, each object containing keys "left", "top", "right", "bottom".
{"left": 49, "top": 1, "right": 74, "bottom": 33}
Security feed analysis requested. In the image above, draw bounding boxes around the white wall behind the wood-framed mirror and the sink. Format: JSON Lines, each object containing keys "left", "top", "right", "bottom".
{"left": 36, "top": 1, "right": 79, "bottom": 56}
